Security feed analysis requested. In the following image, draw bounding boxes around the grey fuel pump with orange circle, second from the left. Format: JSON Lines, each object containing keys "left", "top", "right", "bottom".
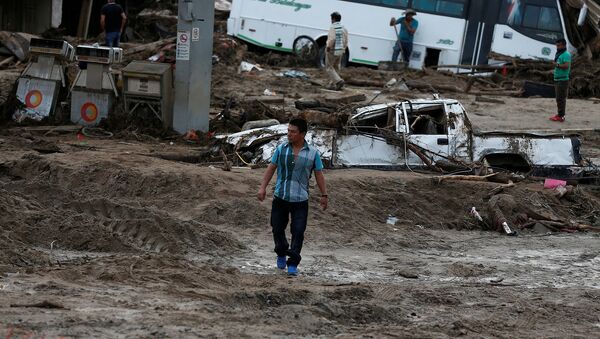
{"left": 71, "top": 45, "right": 123, "bottom": 126}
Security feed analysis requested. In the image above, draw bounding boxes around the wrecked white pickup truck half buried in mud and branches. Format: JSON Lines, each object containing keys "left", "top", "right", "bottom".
{"left": 219, "top": 99, "right": 583, "bottom": 177}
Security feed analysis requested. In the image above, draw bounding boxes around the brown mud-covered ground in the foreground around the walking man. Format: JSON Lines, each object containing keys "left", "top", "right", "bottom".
{"left": 0, "top": 130, "right": 600, "bottom": 338}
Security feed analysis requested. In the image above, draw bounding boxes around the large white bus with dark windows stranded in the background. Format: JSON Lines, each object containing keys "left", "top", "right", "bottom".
{"left": 227, "top": 0, "right": 573, "bottom": 71}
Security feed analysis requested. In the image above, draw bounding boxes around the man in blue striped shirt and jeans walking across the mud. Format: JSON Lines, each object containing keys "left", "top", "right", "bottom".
{"left": 258, "top": 119, "right": 328, "bottom": 276}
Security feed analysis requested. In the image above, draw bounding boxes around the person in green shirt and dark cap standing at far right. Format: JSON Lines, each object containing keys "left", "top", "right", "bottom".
{"left": 550, "top": 39, "right": 571, "bottom": 122}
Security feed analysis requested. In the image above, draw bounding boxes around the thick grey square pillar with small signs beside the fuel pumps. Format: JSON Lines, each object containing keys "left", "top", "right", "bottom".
{"left": 173, "top": 0, "right": 215, "bottom": 133}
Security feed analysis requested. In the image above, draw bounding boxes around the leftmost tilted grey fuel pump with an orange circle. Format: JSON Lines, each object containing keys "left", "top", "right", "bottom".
{"left": 14, "top": 38, "right": 74, "bottom": 121}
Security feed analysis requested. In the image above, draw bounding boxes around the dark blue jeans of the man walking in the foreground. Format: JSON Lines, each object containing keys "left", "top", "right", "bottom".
{"left": 271, "top": 197, "right": 308, "bottom": 266}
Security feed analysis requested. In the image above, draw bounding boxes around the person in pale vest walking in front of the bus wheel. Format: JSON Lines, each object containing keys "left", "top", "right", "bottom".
{"left": 325, "top": 12, "right": 348, "bottom": 91}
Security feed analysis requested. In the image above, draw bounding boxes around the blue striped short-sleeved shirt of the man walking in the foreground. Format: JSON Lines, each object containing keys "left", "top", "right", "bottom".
{"left": 271, "top": 141, "right": 323, "bottom": 202}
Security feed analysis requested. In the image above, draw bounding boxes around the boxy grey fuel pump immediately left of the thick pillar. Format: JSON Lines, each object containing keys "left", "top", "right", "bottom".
{"left": 121, "top": 61, "right": 173, "bottom": 128}
